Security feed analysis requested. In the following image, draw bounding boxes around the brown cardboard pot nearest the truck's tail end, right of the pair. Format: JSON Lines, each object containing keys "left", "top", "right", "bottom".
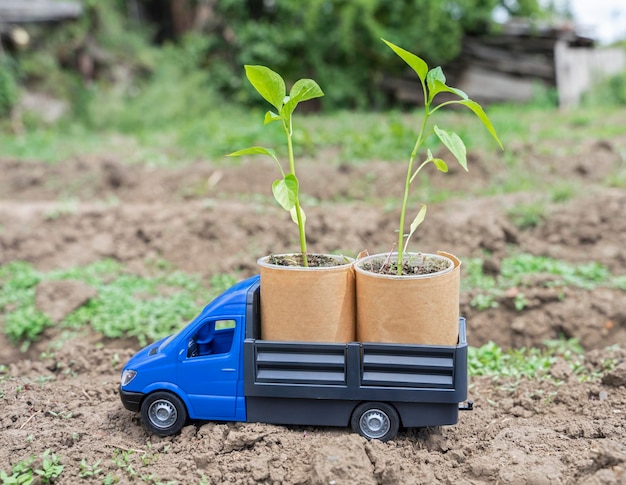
{"left": 355, "top": 251, "right": 461, "bottom": 345}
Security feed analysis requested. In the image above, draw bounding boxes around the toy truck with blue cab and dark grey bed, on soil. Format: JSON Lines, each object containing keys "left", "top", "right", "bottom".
{"left": 120, "top": 275, "right": 468, "bottom": 441}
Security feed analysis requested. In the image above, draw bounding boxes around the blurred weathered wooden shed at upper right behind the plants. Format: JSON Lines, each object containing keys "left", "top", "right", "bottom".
{"left": 384, "top": 22, "right": 626, "bottom": 107}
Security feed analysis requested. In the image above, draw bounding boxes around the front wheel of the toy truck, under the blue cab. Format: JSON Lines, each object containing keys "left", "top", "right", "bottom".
{"left": 141, "top": 391, "right": 187, "bottom": 436}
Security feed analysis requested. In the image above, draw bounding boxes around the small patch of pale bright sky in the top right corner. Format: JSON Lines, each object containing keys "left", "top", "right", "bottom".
{"left": 569, "top": 0, "right": 626, "bottom": 44}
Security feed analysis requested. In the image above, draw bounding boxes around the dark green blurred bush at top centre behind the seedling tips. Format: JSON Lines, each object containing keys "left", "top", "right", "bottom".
{"left": 207, "top": 0, "right": 541, "bottom": 108}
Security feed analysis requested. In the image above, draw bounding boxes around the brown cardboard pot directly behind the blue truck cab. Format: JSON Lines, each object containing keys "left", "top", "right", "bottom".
{"left": 258, "top": 256, "right": 356, "bottom": 342}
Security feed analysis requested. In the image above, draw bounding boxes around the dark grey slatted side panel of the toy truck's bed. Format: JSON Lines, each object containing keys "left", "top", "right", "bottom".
{"left": 244, "top": 318, "right": 467, "bottom": 403}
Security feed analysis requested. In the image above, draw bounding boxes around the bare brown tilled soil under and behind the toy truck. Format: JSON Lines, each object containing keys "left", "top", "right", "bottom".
{"left": 0, "top": 134, "right": 626, "bottom": 484}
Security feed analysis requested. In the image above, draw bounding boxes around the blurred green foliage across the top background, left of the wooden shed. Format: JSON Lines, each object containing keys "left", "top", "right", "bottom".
{"left": 0, "top": 0, "right": 542, "bottom": 118}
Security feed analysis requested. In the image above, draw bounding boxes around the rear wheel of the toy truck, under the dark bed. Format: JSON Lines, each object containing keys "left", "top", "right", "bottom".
{"left": 350, "top": 402, "right": 400, "bottom": 441}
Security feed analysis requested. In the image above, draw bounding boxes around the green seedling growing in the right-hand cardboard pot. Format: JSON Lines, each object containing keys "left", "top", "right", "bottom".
{"left": 382, "top": 39, "right": 502, "bottom": 275}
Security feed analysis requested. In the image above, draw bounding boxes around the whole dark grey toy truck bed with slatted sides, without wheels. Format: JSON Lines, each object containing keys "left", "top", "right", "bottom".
{"left": 244, "top": 278, "right": 467, "bottom": 426}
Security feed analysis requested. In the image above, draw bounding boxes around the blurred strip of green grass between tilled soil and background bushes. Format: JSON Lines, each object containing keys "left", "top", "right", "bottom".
{"left": 0, "top": 99, "right": 626, "bottom": 164}
